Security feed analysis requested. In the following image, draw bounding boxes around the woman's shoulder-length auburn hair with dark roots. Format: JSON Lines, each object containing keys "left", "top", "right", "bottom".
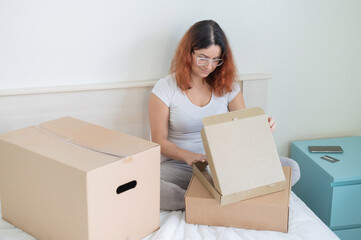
{"left": 170, "top": 20, "right": 237, "bottom": 96}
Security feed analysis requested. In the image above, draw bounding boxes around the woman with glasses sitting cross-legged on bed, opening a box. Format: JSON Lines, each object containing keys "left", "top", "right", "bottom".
{"left": 149, "top": 20, "right": 299, "bottom": 210}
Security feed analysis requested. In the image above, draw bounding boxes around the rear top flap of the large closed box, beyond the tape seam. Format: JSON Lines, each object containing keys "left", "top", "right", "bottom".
{"left": 38, "top": 117, "right": 157, "bottom": 157}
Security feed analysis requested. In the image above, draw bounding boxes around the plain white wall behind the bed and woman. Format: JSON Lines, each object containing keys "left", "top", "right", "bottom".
{"left": 0, "top": 0, "right": 361, "bottom": 155}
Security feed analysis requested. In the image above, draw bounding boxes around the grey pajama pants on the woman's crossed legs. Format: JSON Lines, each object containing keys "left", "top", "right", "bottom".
{"left": 160, "top": 157, "right": 301, "bottom": 211}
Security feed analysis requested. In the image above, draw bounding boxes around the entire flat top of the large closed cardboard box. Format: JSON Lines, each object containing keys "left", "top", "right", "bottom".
{"left": 0, "top": 117, "right": 158, "bottom": 171}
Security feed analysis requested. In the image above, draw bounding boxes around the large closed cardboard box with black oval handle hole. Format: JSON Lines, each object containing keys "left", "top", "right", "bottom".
{"left": 0, "top": 117, "right": 160, "bottom": 240}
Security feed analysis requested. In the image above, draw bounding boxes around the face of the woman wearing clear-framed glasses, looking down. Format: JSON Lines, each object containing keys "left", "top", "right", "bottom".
{"left": 191, "top": 45, "right": 221, "bottom": 79}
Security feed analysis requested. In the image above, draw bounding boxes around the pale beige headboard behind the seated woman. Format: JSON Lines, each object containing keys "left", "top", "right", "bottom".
{"left": 0, "top": 74, "right": 271, "bottom": 139}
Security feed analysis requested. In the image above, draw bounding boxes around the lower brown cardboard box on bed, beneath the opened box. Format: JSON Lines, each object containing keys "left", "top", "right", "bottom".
{"left": 185, "top": 167, "right": 291, "bottom": 232}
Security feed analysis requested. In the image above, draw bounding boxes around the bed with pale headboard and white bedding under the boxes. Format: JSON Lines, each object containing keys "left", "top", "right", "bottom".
{"left": 0, "top": 74, "right": 339, "bottom": 240}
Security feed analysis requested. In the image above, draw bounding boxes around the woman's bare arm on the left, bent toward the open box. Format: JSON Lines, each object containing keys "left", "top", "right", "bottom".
{"left": 149, "top": 93, "right": 207, "bottom": 165}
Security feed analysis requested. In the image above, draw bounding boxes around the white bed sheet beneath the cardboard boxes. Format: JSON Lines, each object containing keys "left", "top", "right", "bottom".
{"left": 0, "top": 192, "right": 339, "bottom": 240}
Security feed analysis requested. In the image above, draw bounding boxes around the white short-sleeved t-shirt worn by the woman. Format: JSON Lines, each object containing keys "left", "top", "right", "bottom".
{"left": 152, "top": 75, "right": 240, "bottom": 162}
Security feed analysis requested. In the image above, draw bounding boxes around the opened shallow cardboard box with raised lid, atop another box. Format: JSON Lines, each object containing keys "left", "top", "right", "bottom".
{"left": 193, "top": 108, "right": 286, "bottom": 205}
